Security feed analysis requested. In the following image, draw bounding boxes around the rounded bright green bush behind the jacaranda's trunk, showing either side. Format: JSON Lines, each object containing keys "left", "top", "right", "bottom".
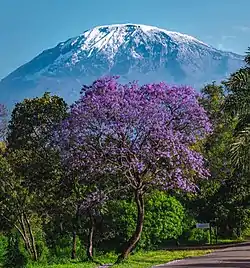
{"left": 103, "top": 191, "right": 185, "bottom": 249}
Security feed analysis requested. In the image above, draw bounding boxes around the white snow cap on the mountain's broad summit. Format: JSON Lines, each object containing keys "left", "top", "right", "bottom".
{"left": 61, "top": 24, "right": 208, "bottom": 57}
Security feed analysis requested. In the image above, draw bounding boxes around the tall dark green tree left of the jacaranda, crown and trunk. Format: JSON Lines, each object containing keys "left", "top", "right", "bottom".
{"left": 6, "top": 93, "right": 67, "bottom": 260}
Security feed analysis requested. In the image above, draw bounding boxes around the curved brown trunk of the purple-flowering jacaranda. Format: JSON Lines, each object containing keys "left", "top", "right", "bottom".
{"left": 116, "top": 191, "right": 144, "bottom": 264}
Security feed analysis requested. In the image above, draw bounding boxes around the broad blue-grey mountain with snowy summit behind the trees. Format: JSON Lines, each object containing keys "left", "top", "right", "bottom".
{"left": 0, "top": 24, "right": 243, "bottom": 107}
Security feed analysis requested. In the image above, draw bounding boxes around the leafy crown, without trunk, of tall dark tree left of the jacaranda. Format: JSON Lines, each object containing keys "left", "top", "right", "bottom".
{"left": 7, "top": 93, "right": 67, "bottom": 202}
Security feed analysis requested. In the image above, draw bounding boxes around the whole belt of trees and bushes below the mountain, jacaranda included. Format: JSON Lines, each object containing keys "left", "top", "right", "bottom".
{"left": 0, "top": 47, "right": 250, "bottom": 267}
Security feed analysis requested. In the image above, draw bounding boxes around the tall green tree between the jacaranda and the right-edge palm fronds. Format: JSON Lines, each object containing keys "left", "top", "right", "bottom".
{"left": 184, "top": 83, "right": 243, "bottom": 237}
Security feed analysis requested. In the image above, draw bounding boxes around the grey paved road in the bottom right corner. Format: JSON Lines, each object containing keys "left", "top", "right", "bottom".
{"left": 155, "top": 243, "right": 250, "bottom": 268}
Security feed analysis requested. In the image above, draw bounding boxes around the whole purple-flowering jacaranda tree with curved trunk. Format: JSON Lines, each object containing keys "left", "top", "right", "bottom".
{"left": 56, "top": 77, "right": 211, "bottom": 262}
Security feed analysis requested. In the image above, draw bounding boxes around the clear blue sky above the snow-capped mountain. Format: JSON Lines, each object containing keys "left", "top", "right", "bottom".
{"left": 0, "top": 0, "right": 250, "bottom": 79}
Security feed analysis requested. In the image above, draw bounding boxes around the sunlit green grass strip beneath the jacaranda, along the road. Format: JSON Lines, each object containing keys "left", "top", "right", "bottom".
{"left": 28, "top": 250, "right": 211, "bottom": 268}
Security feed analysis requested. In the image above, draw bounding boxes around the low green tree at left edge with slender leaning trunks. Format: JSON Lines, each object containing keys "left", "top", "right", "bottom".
{"left": 0, "top": 155, "right": 38, "bottom": 260}
